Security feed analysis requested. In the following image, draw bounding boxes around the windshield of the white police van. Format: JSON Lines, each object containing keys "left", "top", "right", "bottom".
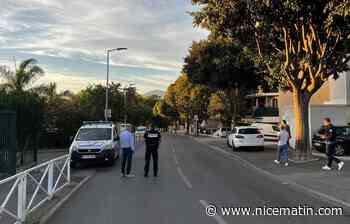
{"left": 76, "top": 128, "right": 112, "bottom": 141}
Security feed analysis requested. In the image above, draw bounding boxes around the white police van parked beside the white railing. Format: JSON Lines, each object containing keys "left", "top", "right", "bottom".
{"left": 69, "top": 121, "right": 119, "bottom": 167}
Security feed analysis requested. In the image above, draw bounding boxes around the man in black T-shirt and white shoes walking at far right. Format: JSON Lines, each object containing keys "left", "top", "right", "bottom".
{"left": 321, "top": 117, "right": 344, "bottom": 170}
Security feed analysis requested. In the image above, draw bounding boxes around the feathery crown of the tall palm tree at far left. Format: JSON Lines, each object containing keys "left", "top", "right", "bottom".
{"left": 0, "top": 58, "right": 44, "bottom": 93}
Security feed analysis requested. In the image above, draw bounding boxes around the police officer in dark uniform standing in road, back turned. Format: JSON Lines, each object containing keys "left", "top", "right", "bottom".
{"left": 144, "top": 125, "right": 161, "bottom": 177}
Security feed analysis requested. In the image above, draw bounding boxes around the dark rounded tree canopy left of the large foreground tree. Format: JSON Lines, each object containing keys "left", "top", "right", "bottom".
{"left": 183, "top": 39, "right": 261, "bottom": 89}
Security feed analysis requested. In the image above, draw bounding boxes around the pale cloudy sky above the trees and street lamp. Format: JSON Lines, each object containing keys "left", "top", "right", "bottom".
{"left": 0, "top": 0, "right": 207, "bottom": 93}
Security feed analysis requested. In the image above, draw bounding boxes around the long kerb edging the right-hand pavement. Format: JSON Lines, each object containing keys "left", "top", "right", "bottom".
{"left": 191, "top": 138, "right": 350, "bottom": 211}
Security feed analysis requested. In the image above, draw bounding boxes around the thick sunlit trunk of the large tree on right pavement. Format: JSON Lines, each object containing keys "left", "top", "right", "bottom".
{"left": 293, "top": 90, "right": 312, "bottom": 160}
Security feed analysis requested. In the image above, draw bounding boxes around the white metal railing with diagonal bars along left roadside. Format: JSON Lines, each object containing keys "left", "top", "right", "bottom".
{"left": 0, "top": 154, "right": 70, "bottom": 224}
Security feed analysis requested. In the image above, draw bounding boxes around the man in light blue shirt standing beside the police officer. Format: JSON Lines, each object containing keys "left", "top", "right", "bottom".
{"left": 119, "top": 128, "right": 135, "bottom": 177}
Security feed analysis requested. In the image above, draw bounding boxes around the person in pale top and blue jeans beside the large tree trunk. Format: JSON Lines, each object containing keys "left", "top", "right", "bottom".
{"left": 274, "top": 122, "right": 289, "bottom": 166}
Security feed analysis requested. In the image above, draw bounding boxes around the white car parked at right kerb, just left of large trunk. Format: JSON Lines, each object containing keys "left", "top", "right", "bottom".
{"left": 227, "top": 126, "right": 264, "bottom": 151}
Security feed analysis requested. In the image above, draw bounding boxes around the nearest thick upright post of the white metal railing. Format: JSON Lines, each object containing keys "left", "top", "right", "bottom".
{"left": 17, "top": 174, "right": 27, "bottom": 223}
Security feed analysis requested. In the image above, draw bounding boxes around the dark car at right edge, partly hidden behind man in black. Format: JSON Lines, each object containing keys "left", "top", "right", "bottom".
{"left": 312, "top": 126, "right": 350, "bottom": 156}
